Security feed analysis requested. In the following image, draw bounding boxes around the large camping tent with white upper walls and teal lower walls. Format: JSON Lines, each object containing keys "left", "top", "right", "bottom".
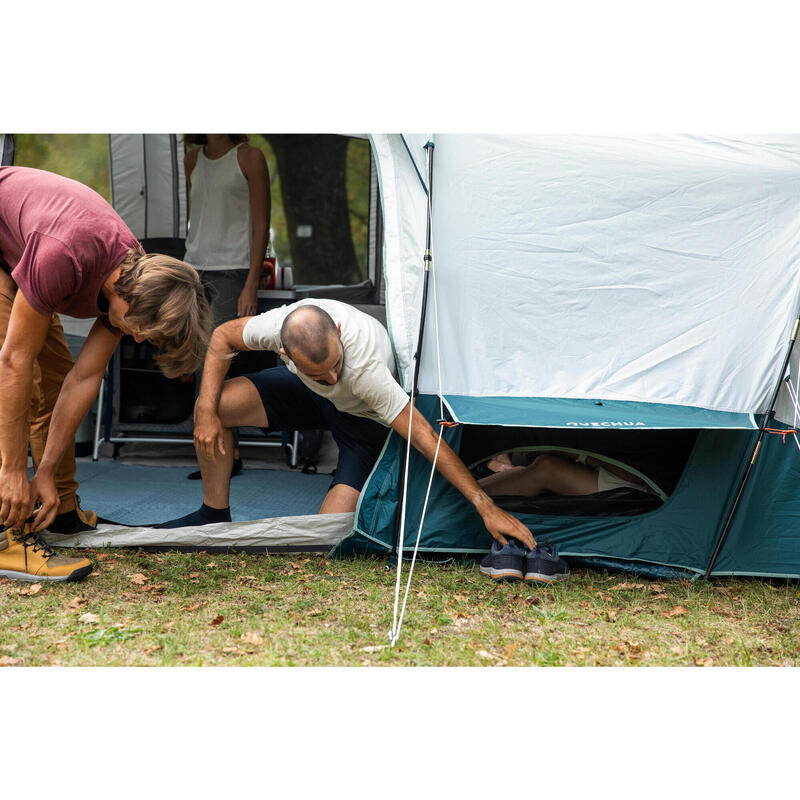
{"left": 6, "top": 135, "right": 800, "bottom": 577}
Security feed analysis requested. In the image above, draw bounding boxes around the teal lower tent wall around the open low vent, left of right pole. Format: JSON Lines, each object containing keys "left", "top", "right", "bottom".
{"left": 336, "top": 395, "right": 756, "bottom": 573}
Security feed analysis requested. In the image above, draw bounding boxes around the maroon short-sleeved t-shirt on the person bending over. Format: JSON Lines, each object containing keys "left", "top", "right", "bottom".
{"left": 0, "top": 167, "right": 139, "bottom": 333}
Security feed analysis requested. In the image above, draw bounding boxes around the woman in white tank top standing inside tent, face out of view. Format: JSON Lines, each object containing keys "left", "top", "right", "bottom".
{"left": 183, "top": 133, "right": 271, "bottom": 479}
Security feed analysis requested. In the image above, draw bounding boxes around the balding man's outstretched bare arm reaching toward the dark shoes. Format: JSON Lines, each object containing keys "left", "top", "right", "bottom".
{"left": 392, "top": 402, "right": 536, "bottom": 548}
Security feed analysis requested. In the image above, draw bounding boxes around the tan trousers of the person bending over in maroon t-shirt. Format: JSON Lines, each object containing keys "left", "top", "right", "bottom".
{"left": 0, "top": 270, "right": 78, "bottom": 514}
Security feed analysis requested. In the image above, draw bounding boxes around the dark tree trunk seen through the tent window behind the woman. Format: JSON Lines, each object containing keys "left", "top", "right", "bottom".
{"left": 263, "top": 134, "right": 360, "bottom": 284}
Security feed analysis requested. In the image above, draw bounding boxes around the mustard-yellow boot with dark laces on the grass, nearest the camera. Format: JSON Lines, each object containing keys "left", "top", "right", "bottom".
{"left": 0, "top": 522, "right": 92, "bottom": 582}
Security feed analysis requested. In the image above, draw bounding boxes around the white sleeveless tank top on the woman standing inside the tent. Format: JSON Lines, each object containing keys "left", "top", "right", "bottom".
{"left": 186, "top": 145, "right": 252, "bottom": 270}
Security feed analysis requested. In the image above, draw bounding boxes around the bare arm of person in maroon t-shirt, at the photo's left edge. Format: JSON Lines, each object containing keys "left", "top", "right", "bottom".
{"left": 0, "top": 291, "right": 50, "bottom": 529}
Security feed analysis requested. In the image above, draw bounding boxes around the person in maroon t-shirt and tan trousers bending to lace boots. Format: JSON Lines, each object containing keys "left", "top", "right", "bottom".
{"left": 0, "top": 167, "right": 212, "bottom": 581}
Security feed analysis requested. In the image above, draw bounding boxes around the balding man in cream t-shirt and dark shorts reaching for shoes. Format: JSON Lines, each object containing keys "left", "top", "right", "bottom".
{"left": 158, "top": 299, "right": 534, "bottom": 547}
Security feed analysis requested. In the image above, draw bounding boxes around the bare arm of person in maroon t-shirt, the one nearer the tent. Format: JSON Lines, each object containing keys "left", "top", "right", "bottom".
{"left": 31, "top": 320, "right": 119, "bottom": 532}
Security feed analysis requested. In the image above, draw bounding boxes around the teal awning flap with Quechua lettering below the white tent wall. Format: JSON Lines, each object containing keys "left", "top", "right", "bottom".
{"left": 444, "top": 394, "right": 758, "bottom": 430}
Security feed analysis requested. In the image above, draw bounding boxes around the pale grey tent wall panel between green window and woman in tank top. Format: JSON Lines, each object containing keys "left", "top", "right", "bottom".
{"left": 109, "top": 133, "right": 187, "bottom": 239}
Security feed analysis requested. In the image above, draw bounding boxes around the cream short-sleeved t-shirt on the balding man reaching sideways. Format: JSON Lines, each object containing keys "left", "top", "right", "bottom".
{"left": 243, "top": 298, "right": 408, "bottom": 426}
